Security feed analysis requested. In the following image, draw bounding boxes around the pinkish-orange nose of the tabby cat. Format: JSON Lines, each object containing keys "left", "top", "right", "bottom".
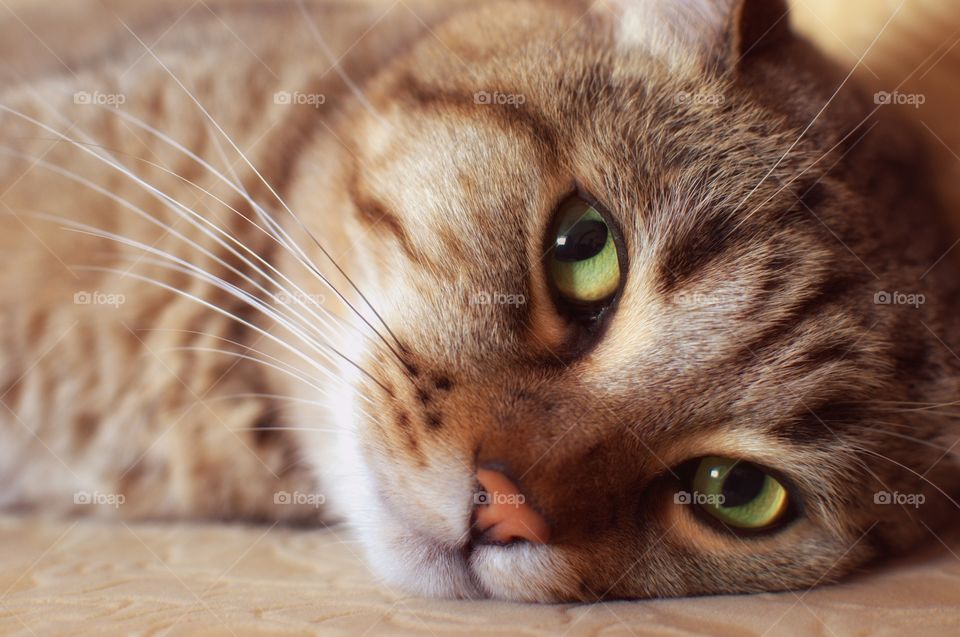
{"left": 474, "top": 469, "right": 550, "bottom": 544}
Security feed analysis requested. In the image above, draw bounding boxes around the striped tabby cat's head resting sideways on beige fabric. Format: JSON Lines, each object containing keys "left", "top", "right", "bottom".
{"left": 290, "top": 0, "right": 957, "bottom": 600}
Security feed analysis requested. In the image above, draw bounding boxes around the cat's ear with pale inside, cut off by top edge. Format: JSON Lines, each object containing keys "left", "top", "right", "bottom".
{"left": 606, "top": 0, "right": 790, "bottom": 71}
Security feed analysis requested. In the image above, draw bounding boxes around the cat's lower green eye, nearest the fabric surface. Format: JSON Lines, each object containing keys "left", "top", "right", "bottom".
{"left": 692, "top": 456, "right": 790, "bottom": 530}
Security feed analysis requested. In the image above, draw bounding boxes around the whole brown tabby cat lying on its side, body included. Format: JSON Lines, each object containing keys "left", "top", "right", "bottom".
{"left": 0, "top": 0, "right": 960, "bottom": 602}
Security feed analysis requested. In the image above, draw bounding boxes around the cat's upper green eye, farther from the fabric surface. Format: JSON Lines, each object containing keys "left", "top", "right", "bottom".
{"left": 547, "top": 195, "right": 620, "bottom": 305}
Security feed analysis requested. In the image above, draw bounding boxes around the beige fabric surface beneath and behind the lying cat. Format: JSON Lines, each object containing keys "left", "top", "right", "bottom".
{"left": 0, "top": 0, "right": 960, "bottom": 637}
